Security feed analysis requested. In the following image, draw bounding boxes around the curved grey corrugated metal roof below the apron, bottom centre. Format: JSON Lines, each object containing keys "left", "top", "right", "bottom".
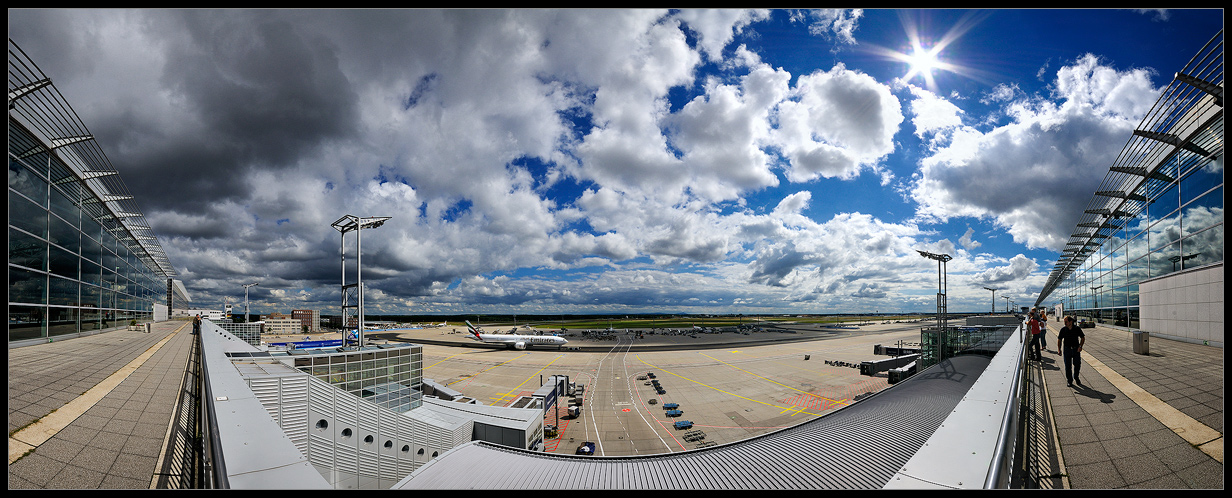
{"left": 394, "top": 355, "right": 991, "bottom": 489}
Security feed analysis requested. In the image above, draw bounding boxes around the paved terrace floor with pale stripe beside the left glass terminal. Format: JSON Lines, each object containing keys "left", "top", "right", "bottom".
{"left": 9, "top": 320, "right": 195, "bottom": 489}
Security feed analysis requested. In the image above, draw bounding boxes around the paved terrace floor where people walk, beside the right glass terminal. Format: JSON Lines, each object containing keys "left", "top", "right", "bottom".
{"left": 1032, "top": 320, "right": 1223, "bottom": 489}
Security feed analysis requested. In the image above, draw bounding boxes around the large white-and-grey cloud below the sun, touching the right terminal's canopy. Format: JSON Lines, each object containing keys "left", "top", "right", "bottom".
{"left": 910, "top": 55, "right": 1158, "bottom": 250}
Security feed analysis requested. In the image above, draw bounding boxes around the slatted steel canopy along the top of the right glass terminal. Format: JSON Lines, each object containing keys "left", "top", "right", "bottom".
{"left": 1035, "top": 30, "right": 1223, "bottom": 306}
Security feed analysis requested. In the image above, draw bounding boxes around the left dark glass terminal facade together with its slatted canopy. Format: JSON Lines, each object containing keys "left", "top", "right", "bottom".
{"left": 9, "top": 39, "right": 178, "bottom": 345}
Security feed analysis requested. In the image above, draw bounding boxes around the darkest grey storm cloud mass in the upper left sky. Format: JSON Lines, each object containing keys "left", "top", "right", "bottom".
{"left": 10, "top": 10, "right": 359, "bottom": 213}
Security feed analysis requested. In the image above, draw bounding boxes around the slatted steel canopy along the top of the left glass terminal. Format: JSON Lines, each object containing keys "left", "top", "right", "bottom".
{"left": 9, "top": 39, "right": 177, "bottom": 277}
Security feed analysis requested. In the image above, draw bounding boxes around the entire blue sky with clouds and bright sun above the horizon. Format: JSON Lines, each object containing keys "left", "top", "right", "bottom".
{"left": 9, "top": 9, "right": 1223, "bottom": 316}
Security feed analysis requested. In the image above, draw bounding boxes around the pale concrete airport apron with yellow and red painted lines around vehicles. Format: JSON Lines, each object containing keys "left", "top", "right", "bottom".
{"left": 372, "top": 323, "right": 920, "bottom": 456}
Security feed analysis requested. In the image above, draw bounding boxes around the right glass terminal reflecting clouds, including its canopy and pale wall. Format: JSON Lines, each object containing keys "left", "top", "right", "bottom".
{"left": 1035, "top": 31, "right": 1225, "bottom": 345}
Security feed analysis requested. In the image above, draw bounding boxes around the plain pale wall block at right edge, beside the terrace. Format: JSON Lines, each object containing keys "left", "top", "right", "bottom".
{"left": 1138, "top": 263, "right": 1223, "bottom": 346}
